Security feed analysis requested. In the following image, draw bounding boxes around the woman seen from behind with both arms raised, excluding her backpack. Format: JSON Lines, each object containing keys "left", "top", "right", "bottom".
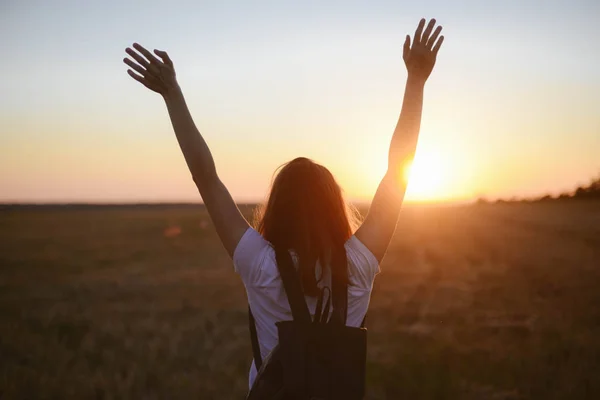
{"left": 123, "top": 19, "right": 444, "bottom": 385}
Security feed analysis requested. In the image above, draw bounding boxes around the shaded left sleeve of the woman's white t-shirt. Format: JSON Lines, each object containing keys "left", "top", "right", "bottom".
{"left": 233, "top": 228, "right": 271, "bottom": 285}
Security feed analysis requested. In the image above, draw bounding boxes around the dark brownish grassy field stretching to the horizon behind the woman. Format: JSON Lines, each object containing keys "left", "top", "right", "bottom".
{"left": 0, "top": 200, "right": 600, "bottom": 400}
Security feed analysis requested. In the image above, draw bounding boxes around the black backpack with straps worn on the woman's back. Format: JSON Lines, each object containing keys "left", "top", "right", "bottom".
{"left": 246, "top": 248, "right": 367, "bottom": 400}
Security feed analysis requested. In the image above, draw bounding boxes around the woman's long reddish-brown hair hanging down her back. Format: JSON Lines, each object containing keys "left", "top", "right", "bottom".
{"left": 255, "top": 157, "right": 358, "bottom": 296}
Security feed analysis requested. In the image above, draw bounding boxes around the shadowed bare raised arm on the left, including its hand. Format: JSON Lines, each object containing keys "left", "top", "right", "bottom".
{"left": 123, "top": 43, "right": 249, "bottom": 257}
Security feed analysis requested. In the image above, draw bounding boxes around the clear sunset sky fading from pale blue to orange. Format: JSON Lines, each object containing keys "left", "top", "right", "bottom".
{"left": 0, "top": 0, "right": 600, "bottom": 202}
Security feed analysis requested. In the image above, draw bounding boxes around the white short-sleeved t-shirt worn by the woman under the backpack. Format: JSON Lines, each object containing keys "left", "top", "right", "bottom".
{"left": 233, "top": 228, "right": 379, "bottom": 387}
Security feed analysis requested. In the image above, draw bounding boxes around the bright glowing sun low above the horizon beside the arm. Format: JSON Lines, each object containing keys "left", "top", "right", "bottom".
{"left": 404, "top": 152, "right": 445, "bottom": 201}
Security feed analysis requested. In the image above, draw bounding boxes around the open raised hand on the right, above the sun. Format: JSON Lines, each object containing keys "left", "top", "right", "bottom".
{"left": 402, "top": 18, "right": 444, "bottom": 81}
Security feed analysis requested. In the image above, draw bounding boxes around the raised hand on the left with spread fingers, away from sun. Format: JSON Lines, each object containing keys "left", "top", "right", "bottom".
{"left": 123, "top": 43, "right": 179, "bottom": 97}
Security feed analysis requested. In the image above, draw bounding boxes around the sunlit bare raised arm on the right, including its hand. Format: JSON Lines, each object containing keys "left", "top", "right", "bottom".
{"left": 356, "top": 19, "right": 444, "bottom": 261}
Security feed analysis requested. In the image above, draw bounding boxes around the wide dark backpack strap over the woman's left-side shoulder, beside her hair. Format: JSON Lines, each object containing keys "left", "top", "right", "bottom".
{"left": 275, "top": 249, "right": 311, "bottom": 323}
